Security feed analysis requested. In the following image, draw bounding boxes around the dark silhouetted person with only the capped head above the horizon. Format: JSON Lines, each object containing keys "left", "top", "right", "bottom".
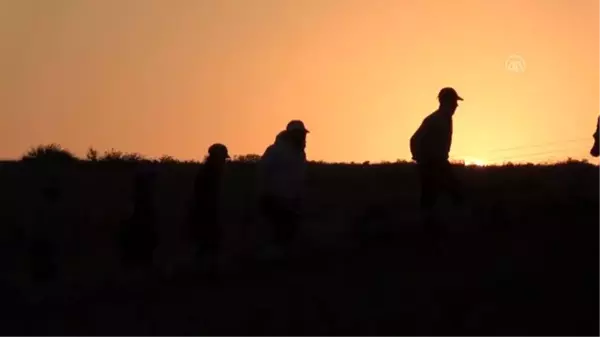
{"left": 190, "top": 143, "right": 230, "bottom": 263}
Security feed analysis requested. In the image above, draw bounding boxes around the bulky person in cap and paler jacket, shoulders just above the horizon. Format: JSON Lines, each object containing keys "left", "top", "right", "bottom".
{"left": 258, "top": 120, "right": 309, "bottom": 253}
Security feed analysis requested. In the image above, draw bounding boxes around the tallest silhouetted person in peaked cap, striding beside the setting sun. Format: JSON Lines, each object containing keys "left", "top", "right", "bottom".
{"left": 410, "top": 87, "right": 463, "bottom": 212}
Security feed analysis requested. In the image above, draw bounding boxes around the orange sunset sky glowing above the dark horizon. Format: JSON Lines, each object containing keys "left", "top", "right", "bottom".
{"left": 0, "top": 0, "right": 600, "bottom": 162}
